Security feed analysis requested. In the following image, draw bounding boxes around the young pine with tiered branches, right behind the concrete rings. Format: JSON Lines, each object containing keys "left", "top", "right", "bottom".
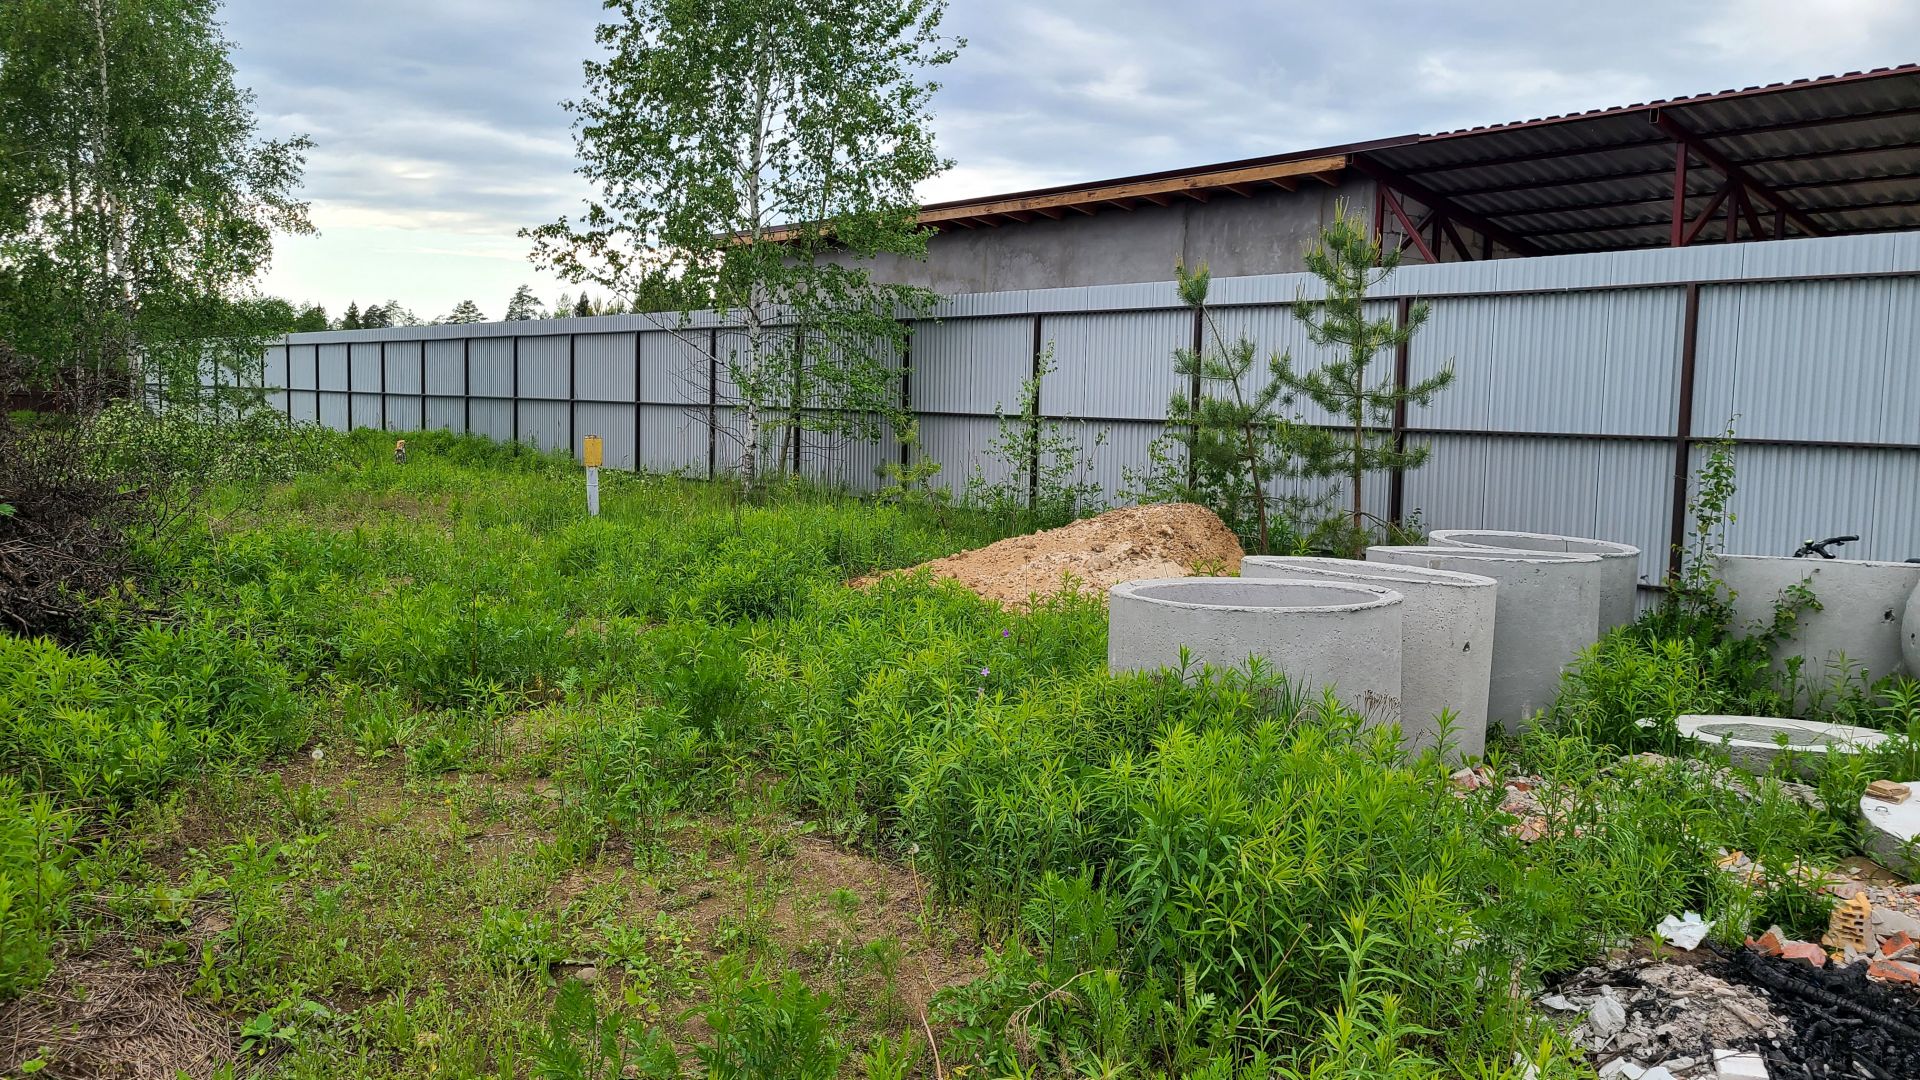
{"left": 1273, "top": 204, "right": 1453, "bottom": 555}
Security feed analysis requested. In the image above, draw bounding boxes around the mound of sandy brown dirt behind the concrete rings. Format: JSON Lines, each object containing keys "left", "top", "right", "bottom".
{"left": 854, "top": 503, "right": 1242, "bottom": 603}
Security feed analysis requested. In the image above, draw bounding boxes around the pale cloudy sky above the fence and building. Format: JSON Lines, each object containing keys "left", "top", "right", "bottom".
{"left": 227, "top": 0, "right": 1920, "bottom": 317}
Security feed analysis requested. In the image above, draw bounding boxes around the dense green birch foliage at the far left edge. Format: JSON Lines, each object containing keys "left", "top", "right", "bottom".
{"left": 0, "top": 0, "right": 311, "bottom": 401}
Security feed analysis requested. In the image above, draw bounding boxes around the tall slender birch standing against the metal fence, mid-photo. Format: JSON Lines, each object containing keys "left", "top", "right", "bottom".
{"left": 528, "top": 0, "right": 962, "bottom": 490}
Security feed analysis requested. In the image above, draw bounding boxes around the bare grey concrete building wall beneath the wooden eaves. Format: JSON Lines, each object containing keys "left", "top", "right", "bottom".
{"left": 817, "top": 179, "right": 1373, "bottom": 292}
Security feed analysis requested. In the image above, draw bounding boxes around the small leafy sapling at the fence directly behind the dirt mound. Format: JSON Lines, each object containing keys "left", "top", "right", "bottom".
{"left": 966, "top": 344, "right": 1106, "bottom": 532}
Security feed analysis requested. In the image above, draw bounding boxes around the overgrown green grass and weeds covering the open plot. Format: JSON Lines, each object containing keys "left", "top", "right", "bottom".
{"left": 0, "top": 424, "right": 1904, "bottom": 1078}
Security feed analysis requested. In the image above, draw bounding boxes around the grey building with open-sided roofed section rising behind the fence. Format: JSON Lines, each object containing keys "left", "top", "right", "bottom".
{"left": 825, "top": 63, "right": 1920, "bottom": 294}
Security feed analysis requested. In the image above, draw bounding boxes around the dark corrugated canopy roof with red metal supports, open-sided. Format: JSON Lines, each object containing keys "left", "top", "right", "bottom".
{"left": 1365, "top": 63, "right": 1920, "bottom": 252}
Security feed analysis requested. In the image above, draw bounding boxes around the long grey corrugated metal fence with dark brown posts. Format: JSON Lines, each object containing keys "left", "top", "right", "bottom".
{"left": 263, "top": 233, "right": 1920, "bottom": 580}
